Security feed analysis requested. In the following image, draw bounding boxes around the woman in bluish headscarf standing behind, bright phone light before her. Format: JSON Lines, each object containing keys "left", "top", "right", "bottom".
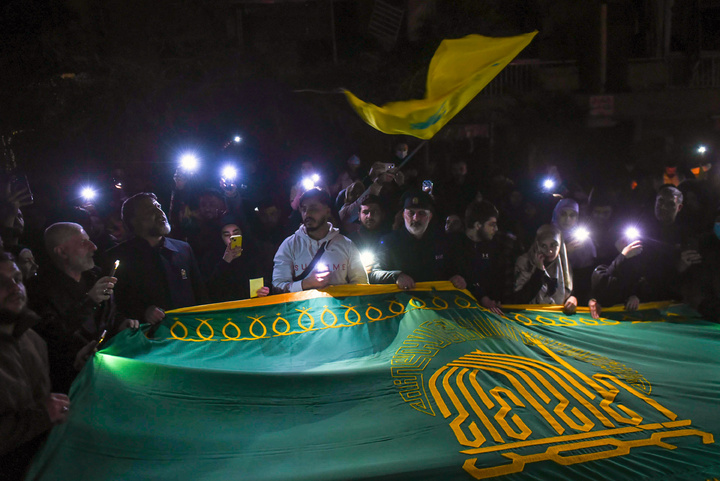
{"left": 552, "top": 199, "right": 597, "bottom": 303}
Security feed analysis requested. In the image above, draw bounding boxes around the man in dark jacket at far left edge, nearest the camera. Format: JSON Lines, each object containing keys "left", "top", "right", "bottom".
{"left": 0, "top": 252, "right": 70, "bottom": 480}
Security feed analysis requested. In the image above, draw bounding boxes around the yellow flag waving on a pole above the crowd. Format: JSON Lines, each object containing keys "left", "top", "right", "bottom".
{"left": 344, "top": 31, "right": 537, "bottom": 139}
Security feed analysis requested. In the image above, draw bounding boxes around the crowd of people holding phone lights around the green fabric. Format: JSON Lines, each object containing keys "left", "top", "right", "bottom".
{"left": 0, "top": 144, "right": 720, "bottom": 479}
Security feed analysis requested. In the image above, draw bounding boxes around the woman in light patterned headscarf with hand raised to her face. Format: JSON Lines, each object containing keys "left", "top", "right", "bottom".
{"left": 515, "top": 224, "right": 599, "bottom": 318}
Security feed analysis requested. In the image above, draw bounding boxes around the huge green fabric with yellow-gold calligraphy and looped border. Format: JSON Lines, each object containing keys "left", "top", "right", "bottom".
{"left": 28, "top": 283, "right": 720, "bottom": 481}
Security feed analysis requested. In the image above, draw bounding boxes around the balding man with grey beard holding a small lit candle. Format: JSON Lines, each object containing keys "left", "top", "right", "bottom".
{"left": 28, "top": 222, "right": 138, "bottom": 392}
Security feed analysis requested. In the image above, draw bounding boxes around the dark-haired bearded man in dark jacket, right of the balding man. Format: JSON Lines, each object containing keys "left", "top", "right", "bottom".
{"left": 105, "top": 192, "right": 207, "bottom": 324}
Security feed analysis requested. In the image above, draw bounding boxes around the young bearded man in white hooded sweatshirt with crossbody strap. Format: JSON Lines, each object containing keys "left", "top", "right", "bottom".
{"left": 273, "top": 189, "right": 368, "bottom": 293}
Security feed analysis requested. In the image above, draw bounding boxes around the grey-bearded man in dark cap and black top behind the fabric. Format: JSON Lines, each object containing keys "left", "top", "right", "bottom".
{"left": 370, "top": 191, "right": 466, "bottom": 289}
